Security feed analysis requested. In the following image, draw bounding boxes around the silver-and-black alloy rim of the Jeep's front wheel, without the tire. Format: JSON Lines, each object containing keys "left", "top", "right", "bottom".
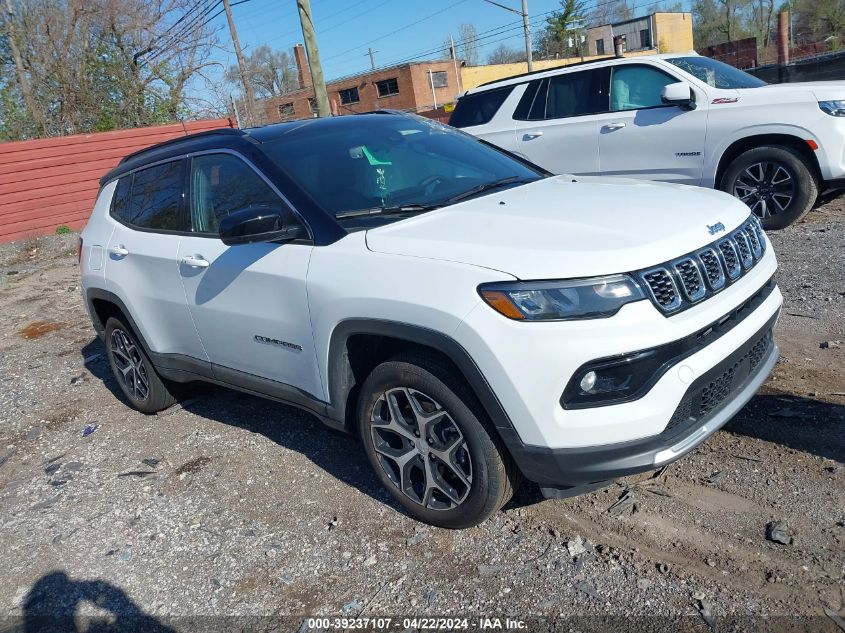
{"left": 370, "top": 387, "right": 473, "bottom": 510}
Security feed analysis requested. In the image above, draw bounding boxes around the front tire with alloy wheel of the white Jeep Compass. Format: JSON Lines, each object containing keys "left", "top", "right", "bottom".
{"left": 358, "top": 354, "right": 519, "bottom": 529}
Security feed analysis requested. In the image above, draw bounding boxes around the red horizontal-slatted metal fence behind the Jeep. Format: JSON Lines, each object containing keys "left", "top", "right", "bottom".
{"left": 0, "top": 119, "right": 232, "bottom": 242}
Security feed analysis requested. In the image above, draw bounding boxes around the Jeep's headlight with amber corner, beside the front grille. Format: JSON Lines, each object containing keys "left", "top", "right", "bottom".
{"left": 478, "top": 275, "right": 646, "bottom": 321}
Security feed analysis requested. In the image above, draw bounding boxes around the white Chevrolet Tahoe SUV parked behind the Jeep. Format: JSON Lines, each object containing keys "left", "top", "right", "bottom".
{"left": 449, "top": 54, "right": 845, "bottom": 229}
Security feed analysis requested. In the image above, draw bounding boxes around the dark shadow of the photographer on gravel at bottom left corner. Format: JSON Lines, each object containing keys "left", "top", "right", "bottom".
{"left": 20, "top": 571, "right": 175, "bottom": 633}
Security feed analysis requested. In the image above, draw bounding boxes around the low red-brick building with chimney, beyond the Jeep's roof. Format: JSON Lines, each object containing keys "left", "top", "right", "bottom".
{"left": 256, "top": 44, "right": 462, "bottom": 123}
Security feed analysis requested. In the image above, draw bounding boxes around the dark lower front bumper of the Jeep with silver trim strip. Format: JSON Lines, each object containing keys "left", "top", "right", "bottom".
{"left": 509, "top": 315, "right": 778, "bottom": 490}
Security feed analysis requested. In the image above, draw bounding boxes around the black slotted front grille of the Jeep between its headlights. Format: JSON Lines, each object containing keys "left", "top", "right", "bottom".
{"left": 637, "top": 214, "right": 766, "bottom": 314}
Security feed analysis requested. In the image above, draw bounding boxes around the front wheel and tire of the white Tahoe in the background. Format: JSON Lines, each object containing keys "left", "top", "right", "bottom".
{"left": 720, "top": 145, "right": 819, "bottom": 229}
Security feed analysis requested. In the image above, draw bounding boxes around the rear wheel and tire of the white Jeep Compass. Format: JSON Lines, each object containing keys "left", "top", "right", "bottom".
{"left": 105, "top": 317, "right": 176, "bottom": 413}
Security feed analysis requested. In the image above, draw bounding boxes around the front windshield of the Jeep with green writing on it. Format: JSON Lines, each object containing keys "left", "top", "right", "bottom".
{"left": 263, "top": 114, "right": 544, "bottom": 229}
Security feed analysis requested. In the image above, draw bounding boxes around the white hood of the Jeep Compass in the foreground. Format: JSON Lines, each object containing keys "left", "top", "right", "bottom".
{"left": 367, "top": 176, "right": 749, "bottom": 279}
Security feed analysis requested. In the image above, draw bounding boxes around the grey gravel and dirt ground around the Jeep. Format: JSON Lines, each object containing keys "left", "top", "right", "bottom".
{"left": 0, "top": 197, "right": 845, "bottom": 633}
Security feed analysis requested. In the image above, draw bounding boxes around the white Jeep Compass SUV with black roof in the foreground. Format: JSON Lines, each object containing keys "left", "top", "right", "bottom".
{"left": 80, "top": 112, "right": 782, "bottom": 528}
